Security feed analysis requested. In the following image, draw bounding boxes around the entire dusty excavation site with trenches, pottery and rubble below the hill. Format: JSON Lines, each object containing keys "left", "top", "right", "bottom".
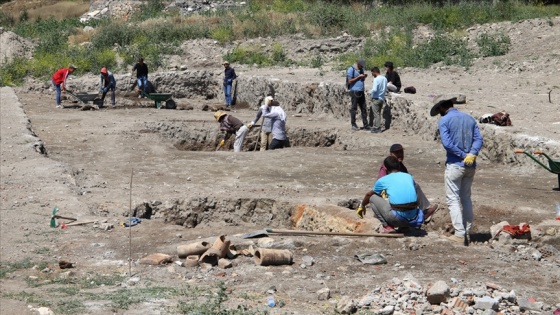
{"left": 0, "top": 5, "right": 560, "bottom": 315}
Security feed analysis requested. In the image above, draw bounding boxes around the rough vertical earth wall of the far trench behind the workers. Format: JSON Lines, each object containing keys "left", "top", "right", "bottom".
{"left": 61, "top": 70, "right": 560, "bottom": 168}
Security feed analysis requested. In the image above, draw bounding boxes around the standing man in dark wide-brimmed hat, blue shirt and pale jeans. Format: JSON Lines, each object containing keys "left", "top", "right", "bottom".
{"left": 430, "top": 98, "right": 484, "bottom": 246}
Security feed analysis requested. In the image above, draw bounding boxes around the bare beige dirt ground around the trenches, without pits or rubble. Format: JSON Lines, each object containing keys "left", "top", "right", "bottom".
{"left": 0, "top": 15, "right": 560, "bottom": 314}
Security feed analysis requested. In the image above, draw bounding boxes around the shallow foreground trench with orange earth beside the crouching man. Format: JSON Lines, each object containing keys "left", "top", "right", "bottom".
{"left": 132, "top": 197, "right": 377, "bottom": 233}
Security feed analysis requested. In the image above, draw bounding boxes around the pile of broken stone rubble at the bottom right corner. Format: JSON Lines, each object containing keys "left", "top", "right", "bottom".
{"left": 336, "top": 274, "right": 560, "bottom": 315}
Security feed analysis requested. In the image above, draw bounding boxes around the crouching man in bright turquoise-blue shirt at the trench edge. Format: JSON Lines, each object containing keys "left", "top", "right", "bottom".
{"left": 357, "top": 156, "right": 424, "bottom": 233}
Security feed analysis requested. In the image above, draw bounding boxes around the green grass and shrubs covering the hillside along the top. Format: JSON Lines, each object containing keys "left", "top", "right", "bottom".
{"left": 0, "top": 0, "right": 560, "bottom": 85}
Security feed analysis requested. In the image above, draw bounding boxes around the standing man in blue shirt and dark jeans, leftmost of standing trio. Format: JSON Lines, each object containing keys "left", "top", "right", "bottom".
{"left": 346, "top": 59, "right": 370, "bottom": 131}
